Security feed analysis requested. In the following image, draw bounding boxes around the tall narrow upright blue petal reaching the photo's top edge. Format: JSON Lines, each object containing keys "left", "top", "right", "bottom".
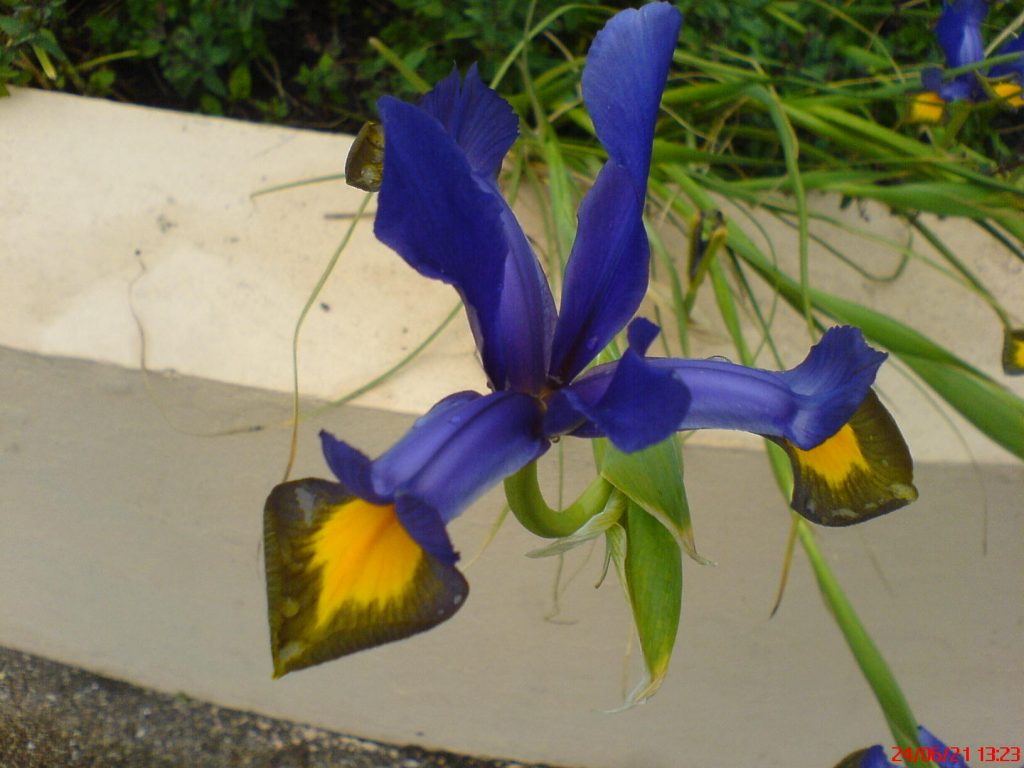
{"left": 549, "top": 3, "right": 682, "bottom": 385}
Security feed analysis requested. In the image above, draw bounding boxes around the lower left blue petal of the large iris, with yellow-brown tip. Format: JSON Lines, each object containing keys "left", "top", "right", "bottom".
{"left": 264, "top": 392, "right": 548, "bottom": 677}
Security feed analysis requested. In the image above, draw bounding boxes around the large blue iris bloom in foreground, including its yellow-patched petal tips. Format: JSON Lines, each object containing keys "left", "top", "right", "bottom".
{"left": 264, "top": 3, "right": 914, "bottom": 675}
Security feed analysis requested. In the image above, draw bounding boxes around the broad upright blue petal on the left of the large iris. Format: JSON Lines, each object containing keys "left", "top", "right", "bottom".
{"left": 374, "top": 87, "right": 555, "bottom": 392}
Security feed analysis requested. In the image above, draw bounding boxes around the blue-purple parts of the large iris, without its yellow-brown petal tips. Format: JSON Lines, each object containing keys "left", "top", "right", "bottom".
{"left": 323, "top": 3, "right": 886, "bottom": 562}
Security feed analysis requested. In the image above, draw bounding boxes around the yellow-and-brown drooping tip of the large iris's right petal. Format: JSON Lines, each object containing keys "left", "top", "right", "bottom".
{"left": 780, "top": 392, "right": 918, "bottom": 525}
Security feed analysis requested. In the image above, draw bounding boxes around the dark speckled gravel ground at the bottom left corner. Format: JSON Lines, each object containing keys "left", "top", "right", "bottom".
{"left": 0, "top": 647, "right": 569, "bottom": 768}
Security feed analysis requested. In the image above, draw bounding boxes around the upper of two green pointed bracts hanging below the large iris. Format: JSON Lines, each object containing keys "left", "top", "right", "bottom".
{"left": 599, "top": 437, "right": 710, "bottom": 565}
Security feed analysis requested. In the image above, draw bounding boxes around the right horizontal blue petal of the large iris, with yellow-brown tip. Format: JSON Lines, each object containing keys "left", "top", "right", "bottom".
{"left": 545, "top": 324, "right": 918, "bottom": 525}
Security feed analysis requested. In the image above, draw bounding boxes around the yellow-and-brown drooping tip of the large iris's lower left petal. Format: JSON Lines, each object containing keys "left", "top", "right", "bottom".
{"left": 263, "top": 479, "right": 469, "bottom": 677}
